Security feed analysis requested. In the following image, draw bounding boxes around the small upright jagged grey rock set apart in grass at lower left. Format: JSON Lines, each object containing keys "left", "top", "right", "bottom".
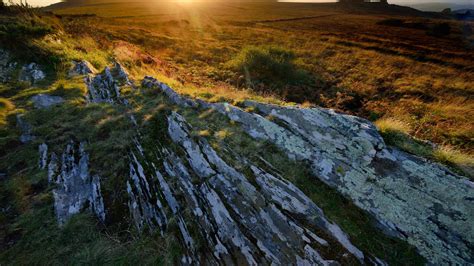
{"left": 39, "top": 141, "right": 105, "bottom": 225}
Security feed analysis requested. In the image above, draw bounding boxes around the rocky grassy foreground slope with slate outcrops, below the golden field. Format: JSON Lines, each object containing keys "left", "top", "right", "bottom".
{"left": 0, "top": 4, "right": 474, "bottom": 265}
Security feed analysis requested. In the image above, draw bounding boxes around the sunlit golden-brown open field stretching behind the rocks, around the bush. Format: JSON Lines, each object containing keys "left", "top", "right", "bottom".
{"left": 50, "top": 3, "right": 474, "bottom": 156}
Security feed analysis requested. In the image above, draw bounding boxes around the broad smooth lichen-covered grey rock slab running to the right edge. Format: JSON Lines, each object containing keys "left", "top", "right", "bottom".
{"left": 142, "top": 77, "right": 474, "bottom": 264}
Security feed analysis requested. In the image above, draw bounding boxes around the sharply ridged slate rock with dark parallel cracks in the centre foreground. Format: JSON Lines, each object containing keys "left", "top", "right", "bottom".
{"left": 127, "top": 112, "right": 366, "bottom": 265}
